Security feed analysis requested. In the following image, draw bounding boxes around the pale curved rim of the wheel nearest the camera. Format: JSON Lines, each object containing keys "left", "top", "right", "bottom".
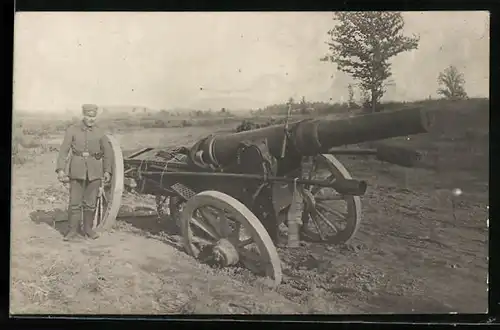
{"left": 180, "top": 191, "right": 282, "bottom": 285}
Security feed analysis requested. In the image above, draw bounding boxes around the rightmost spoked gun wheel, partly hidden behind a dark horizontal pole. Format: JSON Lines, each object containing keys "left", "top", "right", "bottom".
{"left": 301, "top": 154, "right": 361, "bottom": 244}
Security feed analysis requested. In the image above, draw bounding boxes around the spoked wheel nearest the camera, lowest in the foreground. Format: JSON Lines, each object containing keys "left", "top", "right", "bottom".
{"left": 180, "top": 191, "right": 282, "bottom": 285}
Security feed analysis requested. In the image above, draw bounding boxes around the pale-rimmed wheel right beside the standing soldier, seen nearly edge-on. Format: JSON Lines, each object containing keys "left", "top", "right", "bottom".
{"left": 94, "top": 135, "right": 124, "bottom": 231}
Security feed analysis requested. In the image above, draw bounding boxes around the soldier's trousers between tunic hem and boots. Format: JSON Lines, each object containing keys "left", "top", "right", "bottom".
{"left": 69, "top": 179, "right": 101, "bottom": 212}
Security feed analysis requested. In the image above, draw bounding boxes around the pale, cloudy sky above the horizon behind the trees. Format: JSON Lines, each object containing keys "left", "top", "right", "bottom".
{"left": 14, "top": 12, "right": 489, "bottom": 111}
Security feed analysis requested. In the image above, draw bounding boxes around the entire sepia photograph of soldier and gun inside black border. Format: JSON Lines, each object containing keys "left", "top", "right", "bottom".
{"left": 10, "top": 11, "right": 490, "bottom": 316}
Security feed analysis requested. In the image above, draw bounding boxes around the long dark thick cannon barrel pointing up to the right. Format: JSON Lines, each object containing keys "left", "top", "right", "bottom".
{"left": 191, "top": 108, "right": 433, "bottom": 167}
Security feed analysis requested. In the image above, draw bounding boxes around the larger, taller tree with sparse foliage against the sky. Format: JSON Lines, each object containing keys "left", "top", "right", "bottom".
{"left": 321, "top": 11, "right": 420, "bottom": 112}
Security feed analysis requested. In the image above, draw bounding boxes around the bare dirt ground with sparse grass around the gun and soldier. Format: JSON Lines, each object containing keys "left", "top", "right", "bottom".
{"left": 11, "top": 100, "right": 489, "bottom": 314}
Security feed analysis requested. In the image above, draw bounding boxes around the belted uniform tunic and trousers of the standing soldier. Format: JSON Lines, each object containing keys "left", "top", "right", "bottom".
{"left": 56, "top": 121, "right": 111, "bottom": 211}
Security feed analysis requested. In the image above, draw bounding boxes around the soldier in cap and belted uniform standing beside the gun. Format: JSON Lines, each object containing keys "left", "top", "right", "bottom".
{"left": 56, "top": 104, "right": 111, "bottom": 241}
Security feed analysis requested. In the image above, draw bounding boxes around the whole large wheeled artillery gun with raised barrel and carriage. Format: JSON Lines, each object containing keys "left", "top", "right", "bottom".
{"left": 95, "top": 108, "right": 432, "bottom": 284}
